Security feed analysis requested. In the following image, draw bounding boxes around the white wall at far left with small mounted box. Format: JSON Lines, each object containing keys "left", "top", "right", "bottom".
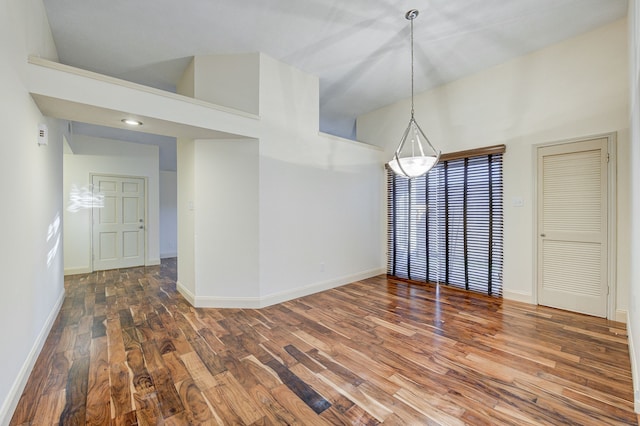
{"left": 0, "top": 0, "right": 64, "bottom": 425}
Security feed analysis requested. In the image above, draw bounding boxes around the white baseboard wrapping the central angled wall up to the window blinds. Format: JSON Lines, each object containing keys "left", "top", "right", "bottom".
{"left": 177, "top": 268, "right": 387, "bottom": 309}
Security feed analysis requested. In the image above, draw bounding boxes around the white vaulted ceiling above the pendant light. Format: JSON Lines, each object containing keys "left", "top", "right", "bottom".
{"left": 44, "top": 0, "right": 627, "bottom": 161}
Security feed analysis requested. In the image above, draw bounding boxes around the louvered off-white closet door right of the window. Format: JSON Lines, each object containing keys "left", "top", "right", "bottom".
{"left": 537, "top": 138, "right": 608, "bottom": 317}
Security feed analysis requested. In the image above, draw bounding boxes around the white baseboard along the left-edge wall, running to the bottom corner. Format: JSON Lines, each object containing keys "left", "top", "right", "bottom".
{"left": 0, "top": 289, "right": 64, "bottom": 426}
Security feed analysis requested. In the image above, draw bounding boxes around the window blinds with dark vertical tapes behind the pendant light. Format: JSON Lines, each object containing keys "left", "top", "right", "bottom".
{"left": 387, "top": 145, "right": 504, "bottom": 296}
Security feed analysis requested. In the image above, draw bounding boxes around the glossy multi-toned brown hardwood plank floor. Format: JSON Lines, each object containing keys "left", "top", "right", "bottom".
{"left": 11, "top": 259, "right": 637, "bottom": 425}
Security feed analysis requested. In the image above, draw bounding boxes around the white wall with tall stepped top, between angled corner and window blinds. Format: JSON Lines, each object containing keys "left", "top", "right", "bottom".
{"left": 260, "top": 55, "right": 386, "bottom": 303}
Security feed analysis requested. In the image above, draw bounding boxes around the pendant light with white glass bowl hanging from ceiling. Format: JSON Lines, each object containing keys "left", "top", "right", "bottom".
{"left": 388, "top": 9, "right": 440, "bottom": 179}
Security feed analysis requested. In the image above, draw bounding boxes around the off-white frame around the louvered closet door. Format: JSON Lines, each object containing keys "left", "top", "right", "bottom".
{"left": 531, "top": 132, "right": 616, "bottom": 322}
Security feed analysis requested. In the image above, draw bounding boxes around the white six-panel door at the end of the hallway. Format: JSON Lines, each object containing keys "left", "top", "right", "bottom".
{"left": 92, "top": 175, "right": 145, "bottom": 271}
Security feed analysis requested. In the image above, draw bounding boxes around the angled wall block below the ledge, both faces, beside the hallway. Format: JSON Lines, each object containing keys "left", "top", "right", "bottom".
{"left": 178, "top": 139, "right": 259, "bottom": 307}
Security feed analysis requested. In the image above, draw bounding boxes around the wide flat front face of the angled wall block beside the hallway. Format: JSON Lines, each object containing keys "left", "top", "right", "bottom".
{"left": 195, "top": 140, "right": 260, "bottom": 306}
